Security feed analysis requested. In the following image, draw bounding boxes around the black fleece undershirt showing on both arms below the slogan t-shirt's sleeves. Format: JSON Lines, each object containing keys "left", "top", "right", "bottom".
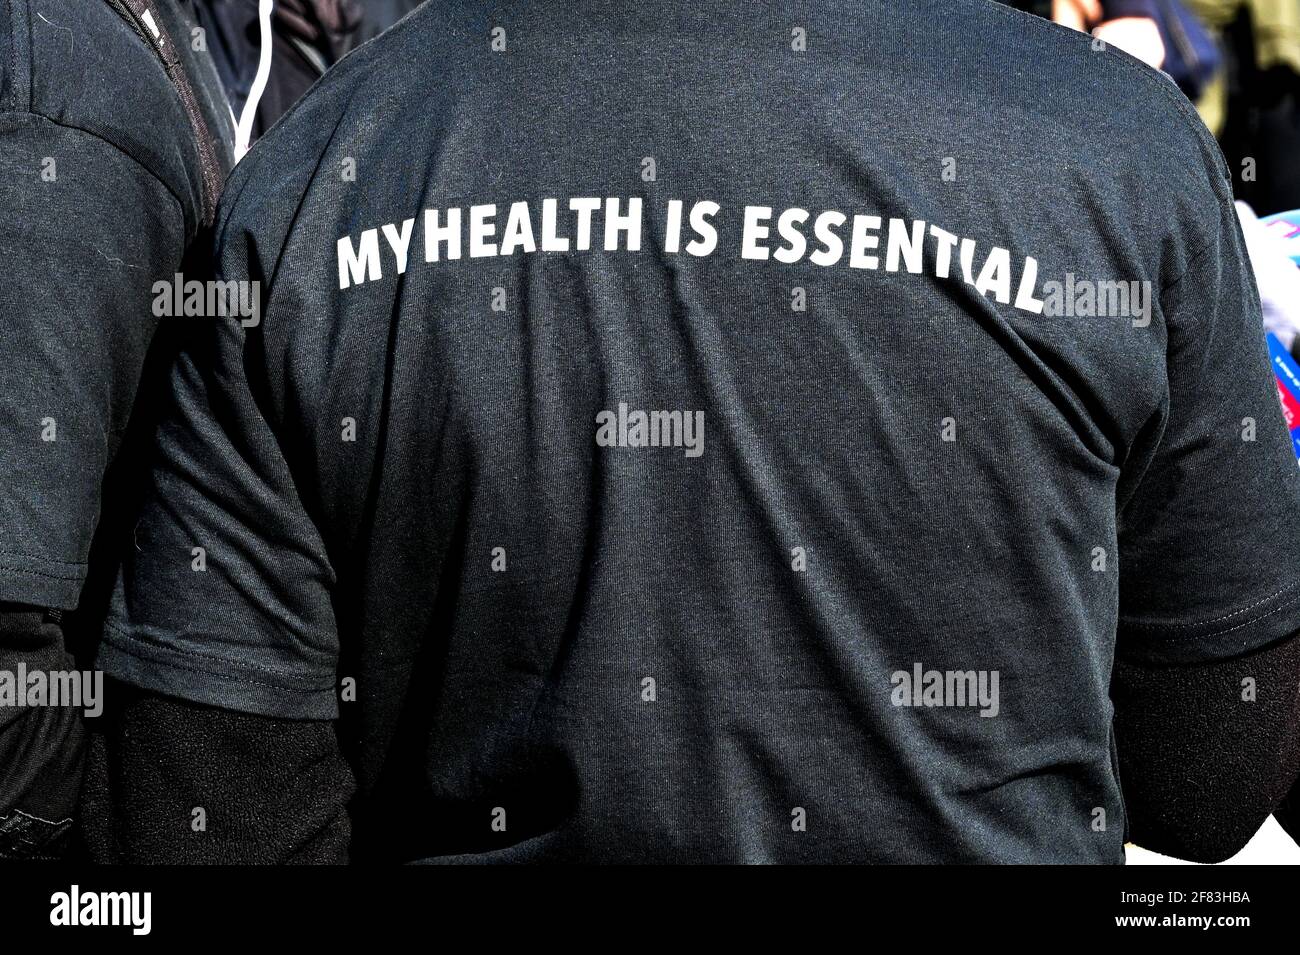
{"left": 82, "top": 635, "right": 1300, "bottom": 863}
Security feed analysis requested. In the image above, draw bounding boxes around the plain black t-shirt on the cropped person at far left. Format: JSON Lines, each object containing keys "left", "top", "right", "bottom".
{"left": 0, "top": 0, "right": 233, "bottom": 609}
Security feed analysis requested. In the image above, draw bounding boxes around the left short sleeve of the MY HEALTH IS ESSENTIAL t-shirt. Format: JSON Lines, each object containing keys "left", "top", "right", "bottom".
{"left": 99, "top": 244, "right": 338, "bottom": 719}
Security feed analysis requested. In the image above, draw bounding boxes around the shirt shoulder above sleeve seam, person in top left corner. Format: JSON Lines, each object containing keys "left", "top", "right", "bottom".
{"left": 0, "top": 0, "right": 202, "bottom": 226}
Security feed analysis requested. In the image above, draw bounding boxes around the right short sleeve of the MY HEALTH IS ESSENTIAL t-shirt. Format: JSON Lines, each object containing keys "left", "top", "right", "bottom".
{"left": 1117, "top": 199, "right": 1300, "bottom": 663}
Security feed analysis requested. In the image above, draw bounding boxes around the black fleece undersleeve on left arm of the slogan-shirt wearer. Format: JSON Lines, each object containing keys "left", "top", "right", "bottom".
{"left": 81, "top": 681, "right": 355, "bottom": 864}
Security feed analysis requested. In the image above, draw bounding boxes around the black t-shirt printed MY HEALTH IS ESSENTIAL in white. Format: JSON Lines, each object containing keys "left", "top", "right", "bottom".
{"left": 101, "top": 0, "right": 1300, "bottom": 861}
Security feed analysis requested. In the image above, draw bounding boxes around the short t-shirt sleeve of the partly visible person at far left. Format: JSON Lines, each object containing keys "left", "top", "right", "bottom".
{"left": 0, "top": 113, "right": 186, "bottom": 609}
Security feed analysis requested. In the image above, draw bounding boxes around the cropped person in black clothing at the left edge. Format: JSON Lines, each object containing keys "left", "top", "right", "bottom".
{"left": 0, "top": 0, "right": 233, "bottom": 859}
